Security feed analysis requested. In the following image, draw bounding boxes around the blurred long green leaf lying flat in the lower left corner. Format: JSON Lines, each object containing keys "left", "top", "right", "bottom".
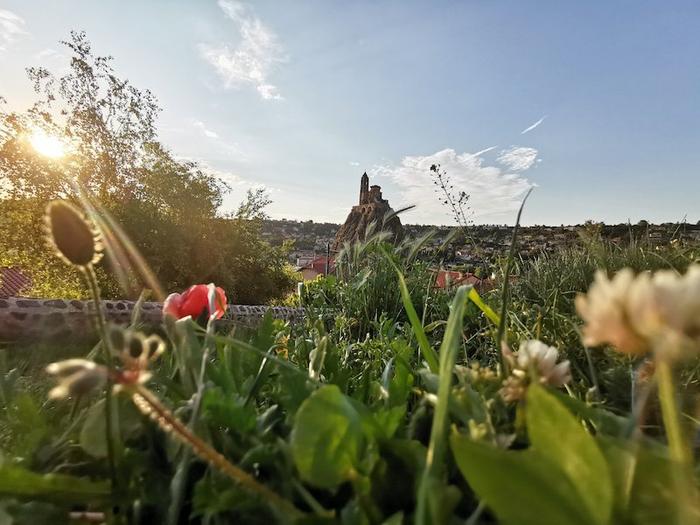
{"left": 0, "top": 465, "right": 110, "bottom": 504}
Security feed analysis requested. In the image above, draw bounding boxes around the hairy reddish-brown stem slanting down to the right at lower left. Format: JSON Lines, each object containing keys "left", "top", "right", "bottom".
{"left": 132, "top": 385, "right": 302, "bottom": 517}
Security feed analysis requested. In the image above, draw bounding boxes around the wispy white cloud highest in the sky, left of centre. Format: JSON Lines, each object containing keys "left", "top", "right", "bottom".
{"left": 199, "top": 0, "right": 285, "bottom": 100}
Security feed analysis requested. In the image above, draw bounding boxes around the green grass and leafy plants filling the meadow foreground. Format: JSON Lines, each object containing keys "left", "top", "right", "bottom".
{"left": 0, "top": 223, "right": 698, "bottom": 524}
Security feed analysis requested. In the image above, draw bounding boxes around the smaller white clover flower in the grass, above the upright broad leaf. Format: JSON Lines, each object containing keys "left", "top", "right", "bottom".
{"left": 501, "top": 340, "right": 571, "bottom": 402}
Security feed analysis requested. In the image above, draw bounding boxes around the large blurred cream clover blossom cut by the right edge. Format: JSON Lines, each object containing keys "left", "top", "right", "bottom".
{"left": 576, "top": 265, "right": 700, "bottom": 355}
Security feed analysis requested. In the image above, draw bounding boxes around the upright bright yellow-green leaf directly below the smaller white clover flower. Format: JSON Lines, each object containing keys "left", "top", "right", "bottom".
{"left": 526, "top": 385, "right": 613, "bottom": 524}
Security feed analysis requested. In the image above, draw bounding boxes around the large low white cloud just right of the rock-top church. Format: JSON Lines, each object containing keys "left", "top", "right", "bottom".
{"left": 370, "top": 149, "right": 532, "bottom": 224}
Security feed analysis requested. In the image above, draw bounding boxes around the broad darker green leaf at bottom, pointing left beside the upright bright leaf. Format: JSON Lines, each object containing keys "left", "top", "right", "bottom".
{"left": 450, "top": 433, "right": 593, "bottom": 525}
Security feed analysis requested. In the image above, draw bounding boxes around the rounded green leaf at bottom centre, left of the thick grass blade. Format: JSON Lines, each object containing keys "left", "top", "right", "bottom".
{"left": 291, "top": 385, "right": 368, "bottom": 489}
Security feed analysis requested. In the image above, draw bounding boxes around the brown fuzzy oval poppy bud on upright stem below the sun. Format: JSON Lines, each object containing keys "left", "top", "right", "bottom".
{"left": 45, "top": 200, "right": 102, "bottom": 267}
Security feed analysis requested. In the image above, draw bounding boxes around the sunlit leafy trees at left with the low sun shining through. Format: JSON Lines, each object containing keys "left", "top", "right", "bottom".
{"left": 0, "top": 32, "right": 292, "bottom": 302}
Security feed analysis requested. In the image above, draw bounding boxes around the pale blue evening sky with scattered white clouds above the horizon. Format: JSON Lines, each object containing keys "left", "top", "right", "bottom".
{"left": 0, "top": 0, "right": 700, "bottom": 225}
